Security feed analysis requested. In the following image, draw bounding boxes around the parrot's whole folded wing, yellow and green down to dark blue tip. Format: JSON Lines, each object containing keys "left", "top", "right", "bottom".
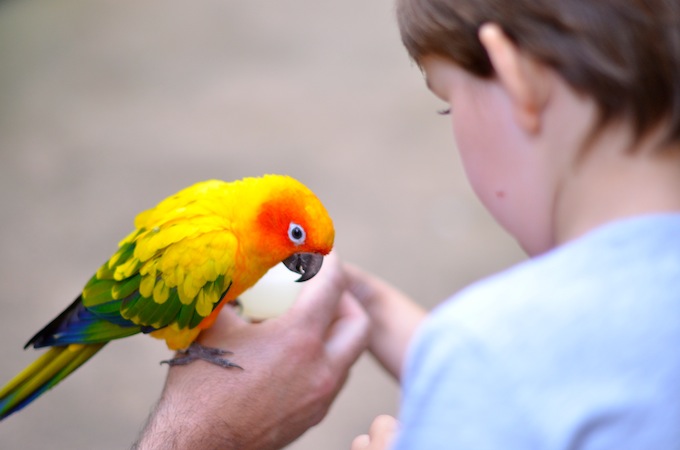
{"left": 26, "top": 186, "right": 238, "bottom": 347}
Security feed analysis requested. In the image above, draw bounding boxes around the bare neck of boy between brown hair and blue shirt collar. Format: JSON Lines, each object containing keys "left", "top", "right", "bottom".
{"left": 553, "top": 127, "right": 680, "bottom": 245}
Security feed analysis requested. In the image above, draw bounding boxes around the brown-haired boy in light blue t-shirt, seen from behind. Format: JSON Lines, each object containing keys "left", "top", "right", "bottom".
{"left": 349, "top": 0, "right": 680, "bottom": 450}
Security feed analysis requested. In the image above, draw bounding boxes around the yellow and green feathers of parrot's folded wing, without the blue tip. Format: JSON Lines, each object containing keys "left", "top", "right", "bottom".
{"left": 82, "top": 215, "right": 238, "bottom": 332}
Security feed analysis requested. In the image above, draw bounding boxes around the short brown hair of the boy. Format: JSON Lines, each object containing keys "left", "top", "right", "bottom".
{"left": 397, "top": 0, "right": 680, "bottom": 143}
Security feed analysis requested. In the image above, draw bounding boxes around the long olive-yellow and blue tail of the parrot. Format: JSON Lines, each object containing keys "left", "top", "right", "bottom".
{"left": 0, "top": 342, "right": 106, "bottom": 420}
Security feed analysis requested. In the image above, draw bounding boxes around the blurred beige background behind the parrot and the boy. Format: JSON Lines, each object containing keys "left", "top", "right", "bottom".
{"left": 0, "top": 0, "right": 522, "bottom": 450}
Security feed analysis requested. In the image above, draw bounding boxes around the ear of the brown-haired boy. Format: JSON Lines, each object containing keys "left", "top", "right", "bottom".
{"left": 479, "top": 23, "right": 550, "bottom": 134}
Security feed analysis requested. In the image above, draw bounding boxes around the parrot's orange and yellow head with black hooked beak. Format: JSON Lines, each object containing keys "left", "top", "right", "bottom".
{"left": 250, "top": 175, "right": 335, "bottom": 281}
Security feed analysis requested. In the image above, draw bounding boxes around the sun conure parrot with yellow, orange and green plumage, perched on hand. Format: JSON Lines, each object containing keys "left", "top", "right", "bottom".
{"left": 0, "top": 175, "right": 334, "bottom": 419}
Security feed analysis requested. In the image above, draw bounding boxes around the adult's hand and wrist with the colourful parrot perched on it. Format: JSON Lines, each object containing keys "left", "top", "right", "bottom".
{"left": 135, "top": 254, "right": 369, "bottom": 450}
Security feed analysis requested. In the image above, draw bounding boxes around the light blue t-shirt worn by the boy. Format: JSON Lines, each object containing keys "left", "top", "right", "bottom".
{"left": 393, "top": 214, "right": 680, "bottom": 450}
